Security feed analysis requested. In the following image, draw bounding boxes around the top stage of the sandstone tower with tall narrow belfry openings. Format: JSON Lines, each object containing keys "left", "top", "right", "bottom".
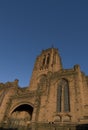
{"left": 34, "top": 47, "right": 62, "bottom": 71}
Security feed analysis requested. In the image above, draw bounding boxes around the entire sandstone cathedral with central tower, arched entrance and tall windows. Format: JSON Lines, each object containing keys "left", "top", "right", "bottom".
{"left": 0, "top": 47, "right": 88, "bottom": 130}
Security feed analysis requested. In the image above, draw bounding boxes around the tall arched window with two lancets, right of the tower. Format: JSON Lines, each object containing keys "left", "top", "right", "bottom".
{"left": 57, "top": 79, "right": 70, "bottom": 112}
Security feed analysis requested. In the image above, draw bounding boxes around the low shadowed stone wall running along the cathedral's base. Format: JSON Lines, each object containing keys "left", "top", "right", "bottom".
{"left": 0, "top": 124, "right": 88, "bottom": 130}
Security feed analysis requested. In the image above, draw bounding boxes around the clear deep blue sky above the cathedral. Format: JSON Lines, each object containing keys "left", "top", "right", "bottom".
{"left": 0, "top": 0, "right": 88, "bottom": 87}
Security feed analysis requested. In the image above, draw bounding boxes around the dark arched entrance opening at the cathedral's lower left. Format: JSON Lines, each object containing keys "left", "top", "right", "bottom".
{"left": 9, "top": 104, "right": 33, "bottom": 129}
